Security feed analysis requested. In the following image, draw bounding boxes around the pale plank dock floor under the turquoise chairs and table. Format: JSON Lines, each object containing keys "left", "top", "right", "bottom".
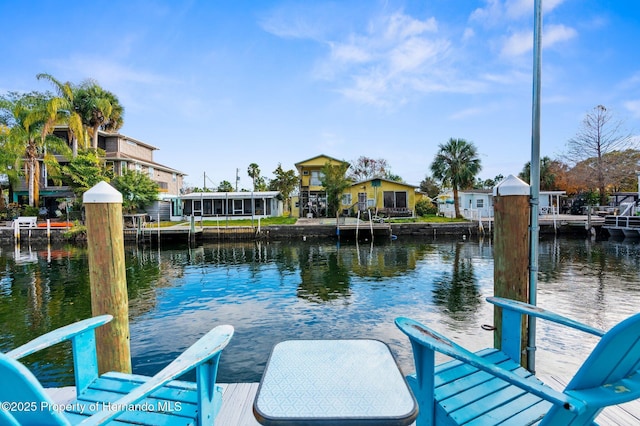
{"left": 47, "top": 376, "right": 640, "bottom": 426}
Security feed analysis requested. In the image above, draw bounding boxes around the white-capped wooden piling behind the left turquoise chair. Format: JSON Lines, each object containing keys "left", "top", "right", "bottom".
{"left": 83, "top": 182, "right": 131, "bottom": 374}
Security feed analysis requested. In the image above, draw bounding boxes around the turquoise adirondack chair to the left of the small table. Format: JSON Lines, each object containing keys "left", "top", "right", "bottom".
{"left": 0, "top": 315, "right": 233, "bottom": 425}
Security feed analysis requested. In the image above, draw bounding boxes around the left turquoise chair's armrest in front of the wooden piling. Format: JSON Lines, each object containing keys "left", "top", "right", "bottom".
{"left": 5, "top": 315, "right": 113, "bottom": 359}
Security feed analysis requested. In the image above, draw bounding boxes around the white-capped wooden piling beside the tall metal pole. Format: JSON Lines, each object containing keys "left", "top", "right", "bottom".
{"left": 493, "top": 175, "right": 530, "bottom": 366}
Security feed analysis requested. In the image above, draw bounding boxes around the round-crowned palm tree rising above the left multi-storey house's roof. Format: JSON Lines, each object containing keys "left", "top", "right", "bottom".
{"left": 73, "top": 80, "right": 124, "bottom": 149}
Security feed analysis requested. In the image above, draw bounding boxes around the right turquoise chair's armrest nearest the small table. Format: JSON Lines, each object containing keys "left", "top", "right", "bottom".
{"left": 395, "top": 317, "right": 586, "bottom": 413}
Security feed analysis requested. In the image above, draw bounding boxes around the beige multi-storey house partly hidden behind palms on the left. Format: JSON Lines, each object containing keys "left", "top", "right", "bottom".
{"left": 13, "top": 128, "right": 186, "bottom": 220}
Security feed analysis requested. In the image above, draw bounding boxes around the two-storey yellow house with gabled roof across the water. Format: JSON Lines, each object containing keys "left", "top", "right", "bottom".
{"left": 295, "top": 154, "right": 349, "bottom": 217}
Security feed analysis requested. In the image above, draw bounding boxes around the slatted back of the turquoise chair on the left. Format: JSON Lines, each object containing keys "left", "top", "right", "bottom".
{"left": 0, "top": 353, "right": 69, "bottom": 425}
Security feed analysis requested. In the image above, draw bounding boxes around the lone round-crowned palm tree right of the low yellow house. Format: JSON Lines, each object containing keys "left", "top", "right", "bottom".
{"left": 431, "top": 138, "right": 482, "bottom": 217}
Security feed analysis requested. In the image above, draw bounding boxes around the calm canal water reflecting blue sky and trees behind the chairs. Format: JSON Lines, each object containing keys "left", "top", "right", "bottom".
{"left": 0, "top": 238, "right": 640, "bottom": 386}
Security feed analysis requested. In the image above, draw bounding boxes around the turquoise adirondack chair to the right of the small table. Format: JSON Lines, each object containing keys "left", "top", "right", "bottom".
{"left": 396, "top": 297, "right": 640, "bottom": 426}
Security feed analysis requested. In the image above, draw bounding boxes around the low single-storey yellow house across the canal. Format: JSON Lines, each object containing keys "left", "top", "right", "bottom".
{"left": 341, "top": 178, "right": 417, "bottom": 216}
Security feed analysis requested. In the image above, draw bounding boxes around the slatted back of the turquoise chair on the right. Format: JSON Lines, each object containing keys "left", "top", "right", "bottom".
{"left": 542, "top": 314, "right": 640, "bottom": 425}
